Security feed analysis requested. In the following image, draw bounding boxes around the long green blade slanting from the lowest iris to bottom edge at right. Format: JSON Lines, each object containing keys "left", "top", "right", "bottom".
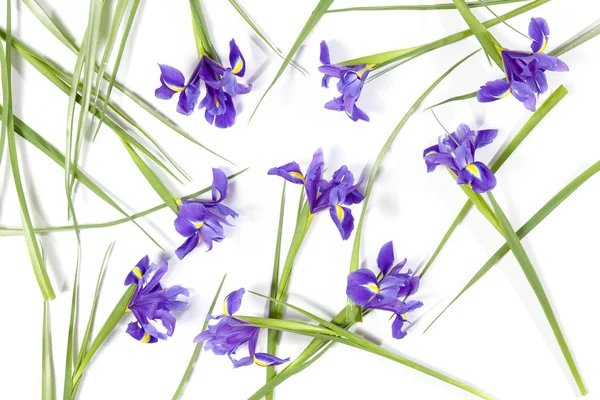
{"left": 250, "top": 292, "right": 491, "bottom": 399}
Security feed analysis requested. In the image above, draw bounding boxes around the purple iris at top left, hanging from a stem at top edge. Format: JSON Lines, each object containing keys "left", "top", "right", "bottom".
{"left": 154, "top": 39, "right": 252, "bottom": 128}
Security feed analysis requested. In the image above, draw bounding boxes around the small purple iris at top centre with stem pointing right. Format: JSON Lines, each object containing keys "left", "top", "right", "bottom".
{"left": 319, "top": 40, "right": 372, "bottom": 122}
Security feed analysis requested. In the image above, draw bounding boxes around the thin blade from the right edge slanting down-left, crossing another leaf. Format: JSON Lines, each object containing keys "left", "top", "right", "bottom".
{"left": 425, "top": 161, "right": 600, "bottom": 332}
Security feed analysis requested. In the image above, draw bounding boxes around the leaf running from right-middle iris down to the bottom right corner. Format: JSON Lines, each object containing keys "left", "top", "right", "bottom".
{"left": 488, "top": 192, "right": 587, "bottom": 396}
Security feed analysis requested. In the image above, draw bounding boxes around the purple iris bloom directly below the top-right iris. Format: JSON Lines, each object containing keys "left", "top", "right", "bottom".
{"left": 423, "top": 124, "right": 498, "bottom": 193}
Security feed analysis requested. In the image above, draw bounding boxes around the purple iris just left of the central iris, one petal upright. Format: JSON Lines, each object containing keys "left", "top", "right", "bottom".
{"left": 175, "top": 168, "right": 238, "bottom": 260}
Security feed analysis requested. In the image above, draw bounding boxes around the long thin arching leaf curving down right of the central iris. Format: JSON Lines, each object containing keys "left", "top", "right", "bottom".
{"left": 347, "top": 50, "right": 479, "bottom": 319}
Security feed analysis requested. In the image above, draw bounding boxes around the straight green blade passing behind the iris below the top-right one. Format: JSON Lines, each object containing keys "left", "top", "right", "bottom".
{"left": 419, "top": 85, "right": 568, "bottom": 278}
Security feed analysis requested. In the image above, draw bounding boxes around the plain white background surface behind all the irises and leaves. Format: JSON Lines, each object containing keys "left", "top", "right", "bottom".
{"left": 0, "top": 0, "right": 600, "bottom": 400}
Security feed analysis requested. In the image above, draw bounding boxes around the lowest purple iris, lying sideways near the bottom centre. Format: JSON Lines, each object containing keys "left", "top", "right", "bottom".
{"left": 194, "top": 288, "right": 290, "bottom": 368}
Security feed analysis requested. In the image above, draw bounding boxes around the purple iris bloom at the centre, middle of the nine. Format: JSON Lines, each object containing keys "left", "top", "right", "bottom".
{"left": 268, "top": 149, "right": 364, "bottom": 240}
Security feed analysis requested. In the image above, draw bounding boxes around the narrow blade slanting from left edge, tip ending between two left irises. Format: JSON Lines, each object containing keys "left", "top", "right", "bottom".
{"left": 9, "top": 108, "right": 164, "bottom": 250}
